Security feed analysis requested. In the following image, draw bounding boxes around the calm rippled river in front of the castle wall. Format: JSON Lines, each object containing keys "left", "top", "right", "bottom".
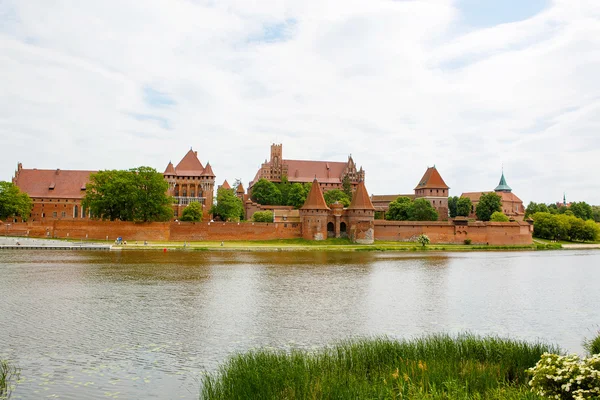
{"left": 0, "top": 250, "right": 600, "bottom": 399}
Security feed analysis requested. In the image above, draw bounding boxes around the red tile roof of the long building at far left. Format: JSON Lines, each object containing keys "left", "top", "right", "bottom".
{"left": 14, "top": 169, "right": 98, "bottom": 199}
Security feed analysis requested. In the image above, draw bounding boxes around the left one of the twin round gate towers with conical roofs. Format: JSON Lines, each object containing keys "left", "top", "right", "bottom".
{"left": 300, "top": 178, "right": 330, "bottom": 240}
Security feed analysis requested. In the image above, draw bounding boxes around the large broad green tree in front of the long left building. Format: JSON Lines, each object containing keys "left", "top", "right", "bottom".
{"left": 82, "top": 167, "right": 173, "bottom": 222}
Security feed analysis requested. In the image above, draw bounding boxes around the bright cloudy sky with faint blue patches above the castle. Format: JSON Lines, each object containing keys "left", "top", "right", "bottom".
{"left": 0, "top": 0, "right": 600, "bottom": 204}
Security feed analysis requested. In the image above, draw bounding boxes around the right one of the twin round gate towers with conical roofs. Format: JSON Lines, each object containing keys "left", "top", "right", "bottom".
{"left": 346, "top": 181, "right": 375, "bottom": 244}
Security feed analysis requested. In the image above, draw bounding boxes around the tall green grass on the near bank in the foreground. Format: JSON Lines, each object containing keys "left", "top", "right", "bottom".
{"left": 200, "top": 335, "right": 559, "bottom": 400}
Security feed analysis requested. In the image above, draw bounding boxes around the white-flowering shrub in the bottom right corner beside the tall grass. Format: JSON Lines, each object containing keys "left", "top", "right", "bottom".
{"left": 528, "top": 353, "right": 600, "bottom": 400}
